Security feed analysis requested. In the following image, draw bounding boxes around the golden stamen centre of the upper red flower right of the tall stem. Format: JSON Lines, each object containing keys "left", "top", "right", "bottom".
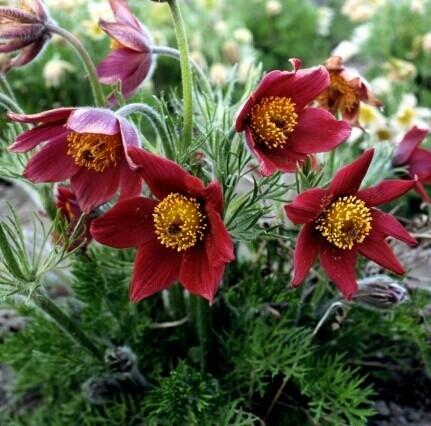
{"left": 250, "top": 96, "right": 298, "bottom": 149}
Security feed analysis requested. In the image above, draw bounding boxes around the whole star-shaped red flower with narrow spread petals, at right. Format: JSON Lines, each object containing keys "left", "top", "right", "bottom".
{"left": 285, "top": 150, "right": 416, "bottom": 298}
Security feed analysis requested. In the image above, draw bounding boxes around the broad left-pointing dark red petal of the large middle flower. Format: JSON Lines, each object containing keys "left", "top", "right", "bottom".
{"left": 91, "top": 197, "right": 157, "bottom": 248}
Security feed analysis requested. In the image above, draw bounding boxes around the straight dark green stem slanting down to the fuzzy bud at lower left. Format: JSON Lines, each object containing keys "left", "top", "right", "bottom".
{"left": 33, "top": 292, "right": 104, "bottom": 360}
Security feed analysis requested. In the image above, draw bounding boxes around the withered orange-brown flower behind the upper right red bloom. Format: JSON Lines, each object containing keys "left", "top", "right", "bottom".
{"left": 317, "top": 56, "right": 382, "bottom": 125}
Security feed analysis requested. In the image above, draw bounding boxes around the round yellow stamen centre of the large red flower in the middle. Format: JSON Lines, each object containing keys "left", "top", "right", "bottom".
{"left": 153, "top": 193, "right": 206, "bottom": 251}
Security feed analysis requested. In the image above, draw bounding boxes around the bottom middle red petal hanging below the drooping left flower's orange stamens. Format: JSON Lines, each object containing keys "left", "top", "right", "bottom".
{"left": 71, "top": 166, "right": 121, "bottom": 213}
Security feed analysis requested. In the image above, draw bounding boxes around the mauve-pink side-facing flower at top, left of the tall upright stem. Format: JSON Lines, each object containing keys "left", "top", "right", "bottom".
{"left": 97, "top": 0, "right": 154, "bottom": 100}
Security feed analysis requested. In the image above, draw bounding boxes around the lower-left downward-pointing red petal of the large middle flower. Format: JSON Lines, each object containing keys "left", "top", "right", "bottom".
{"left": 129, "top": 240, "right": 181, "bottom": 302}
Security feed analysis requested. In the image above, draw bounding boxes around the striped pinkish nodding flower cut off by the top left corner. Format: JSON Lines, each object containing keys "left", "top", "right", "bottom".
{"left": 0, "top": 0, "right": 50, "bottom": 71}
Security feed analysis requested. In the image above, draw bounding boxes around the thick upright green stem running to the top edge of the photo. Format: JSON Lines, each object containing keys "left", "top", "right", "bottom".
{"left": 168, "top": 0, "right": 193, "bottom": 153}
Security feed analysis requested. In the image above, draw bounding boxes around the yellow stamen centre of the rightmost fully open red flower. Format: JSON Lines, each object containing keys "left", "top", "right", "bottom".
{"left": 316, "top": 195, "right": 373, "bottom": 250}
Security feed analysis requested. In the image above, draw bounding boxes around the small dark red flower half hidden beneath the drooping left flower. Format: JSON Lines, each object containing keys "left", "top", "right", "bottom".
{"left": 55, "top": 186, "right": 93, "bottom": 250}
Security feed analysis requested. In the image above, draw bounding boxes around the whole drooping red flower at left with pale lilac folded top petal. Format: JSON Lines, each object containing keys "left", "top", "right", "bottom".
{"left": 9, "top": 108, "right": 141, "bottom": 213}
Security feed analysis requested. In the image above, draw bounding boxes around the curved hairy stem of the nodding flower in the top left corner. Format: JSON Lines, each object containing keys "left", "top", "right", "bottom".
{"left": 47, "top": 24, "right": 105, "bottom": 107}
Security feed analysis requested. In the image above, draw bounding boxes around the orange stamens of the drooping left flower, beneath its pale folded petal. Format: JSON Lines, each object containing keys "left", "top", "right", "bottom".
{"left": 67, "top": 132, "right": 121, "bottom": 172}
